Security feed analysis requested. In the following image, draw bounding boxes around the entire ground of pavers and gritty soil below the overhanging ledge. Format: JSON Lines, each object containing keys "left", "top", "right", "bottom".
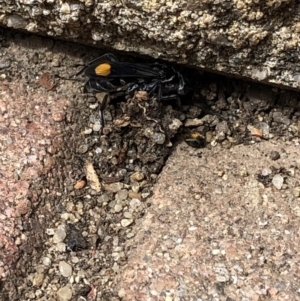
{"left": 0, "top": 29, "right": 300, "bottom": 301}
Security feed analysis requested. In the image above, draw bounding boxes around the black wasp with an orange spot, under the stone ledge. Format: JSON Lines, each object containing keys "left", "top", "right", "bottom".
{"left": 76, "top": 53, "right": 187, "bottom": 100}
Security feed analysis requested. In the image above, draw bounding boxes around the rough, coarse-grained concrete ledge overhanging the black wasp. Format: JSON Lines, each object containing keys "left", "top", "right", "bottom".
{"left": 0, "top": 0, "right": 300, "bottom": 89}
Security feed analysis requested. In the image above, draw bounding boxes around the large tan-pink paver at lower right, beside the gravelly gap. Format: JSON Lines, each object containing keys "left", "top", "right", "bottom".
{"left": 119, "top": 141, "right": 300, "bottom": 301}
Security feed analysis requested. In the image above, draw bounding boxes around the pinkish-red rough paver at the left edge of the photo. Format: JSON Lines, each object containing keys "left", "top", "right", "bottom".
{"left": 0, "top": 81, "right": 68, "bottom": 279}
